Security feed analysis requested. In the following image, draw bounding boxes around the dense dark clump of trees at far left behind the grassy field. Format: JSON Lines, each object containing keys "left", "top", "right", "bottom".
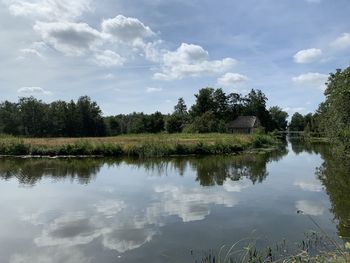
{"left": 0, "top": 96, "right": 106, "bottom": 137}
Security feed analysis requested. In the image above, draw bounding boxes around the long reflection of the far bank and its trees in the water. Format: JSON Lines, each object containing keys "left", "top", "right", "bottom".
{"left": 0, "top": 148, "right": 288, "bottom": 186}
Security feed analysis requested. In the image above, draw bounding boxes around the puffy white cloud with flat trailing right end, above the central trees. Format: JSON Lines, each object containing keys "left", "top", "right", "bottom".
{"left": 153, "top": 43, "right": 236, "bottom": 80}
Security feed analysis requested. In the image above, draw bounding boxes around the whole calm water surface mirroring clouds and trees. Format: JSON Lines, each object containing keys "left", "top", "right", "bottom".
{"left": 0, "top": 139, "right": 350, "bottom": 263}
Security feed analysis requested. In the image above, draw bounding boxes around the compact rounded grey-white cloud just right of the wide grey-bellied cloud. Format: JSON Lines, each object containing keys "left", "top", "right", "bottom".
{"left": 102, "top": 15, "right": 155, "bottom": 44}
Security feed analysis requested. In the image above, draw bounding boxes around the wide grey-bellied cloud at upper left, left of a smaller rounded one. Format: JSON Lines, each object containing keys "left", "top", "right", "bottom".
{"left": 34, "top": 22, "right": 102, "bottom": 56}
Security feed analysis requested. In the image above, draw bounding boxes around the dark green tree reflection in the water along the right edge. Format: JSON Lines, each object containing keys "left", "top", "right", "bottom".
{"left": 316, "top": 147, "right": 350, "bottom": 241}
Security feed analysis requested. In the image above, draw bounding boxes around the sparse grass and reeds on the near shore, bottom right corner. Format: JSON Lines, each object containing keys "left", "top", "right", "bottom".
{"left": 191, "top": 210, "right": 350, "bottom": 263}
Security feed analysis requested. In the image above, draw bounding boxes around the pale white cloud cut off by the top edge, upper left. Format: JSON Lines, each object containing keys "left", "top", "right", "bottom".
{"left": 5, "top": 0, "right": 91, "bottom": 21}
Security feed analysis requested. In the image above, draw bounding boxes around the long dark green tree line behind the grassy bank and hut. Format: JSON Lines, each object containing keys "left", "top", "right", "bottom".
{"left": 0, "top": 88, "right": 288, "bottom": 137}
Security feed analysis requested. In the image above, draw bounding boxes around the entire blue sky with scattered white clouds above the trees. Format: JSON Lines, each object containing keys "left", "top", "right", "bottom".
{"left": 0, "top": 0, "right": 350, "bottom": 115}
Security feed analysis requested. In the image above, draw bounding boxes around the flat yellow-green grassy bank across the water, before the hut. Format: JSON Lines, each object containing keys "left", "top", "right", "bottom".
{"left": 0, "top": 133, "right": 278, "bottom": 157}
